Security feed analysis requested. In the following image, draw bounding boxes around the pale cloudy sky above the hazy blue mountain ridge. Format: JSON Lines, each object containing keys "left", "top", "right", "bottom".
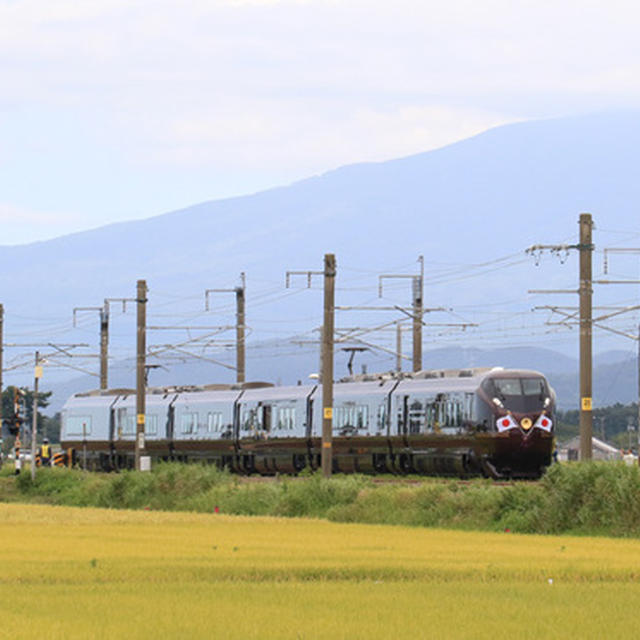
{"left": 0, "top": 0, "right": 640, "bottom": 244}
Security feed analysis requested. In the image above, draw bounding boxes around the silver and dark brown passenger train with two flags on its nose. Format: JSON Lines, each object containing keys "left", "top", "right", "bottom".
{"left": 61, "top": 368, "right": 555, "bottom": 478}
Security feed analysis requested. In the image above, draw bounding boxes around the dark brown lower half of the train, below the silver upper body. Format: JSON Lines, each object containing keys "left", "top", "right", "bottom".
{"left": 59, "top": 433, "right": 552, "bottom": 479}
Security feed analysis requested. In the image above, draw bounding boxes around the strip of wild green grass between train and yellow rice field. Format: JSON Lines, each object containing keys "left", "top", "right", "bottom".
{"left": 0, "top": 463, "right": 640, "bottom": 537}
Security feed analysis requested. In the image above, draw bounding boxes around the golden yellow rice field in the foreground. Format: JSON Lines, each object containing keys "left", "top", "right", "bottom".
{"left": 0, "top": 504, "right": 640, "bottom": 640}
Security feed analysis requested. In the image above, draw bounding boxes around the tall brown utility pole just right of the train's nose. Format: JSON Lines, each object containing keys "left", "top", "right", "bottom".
{"left": 526, "top": 213, "right": 594, "bottom": 460}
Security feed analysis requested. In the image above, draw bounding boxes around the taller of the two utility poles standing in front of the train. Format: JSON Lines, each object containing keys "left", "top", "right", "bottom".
{"left": 286, "top": 253, "right": 336, "bottom": 478}
